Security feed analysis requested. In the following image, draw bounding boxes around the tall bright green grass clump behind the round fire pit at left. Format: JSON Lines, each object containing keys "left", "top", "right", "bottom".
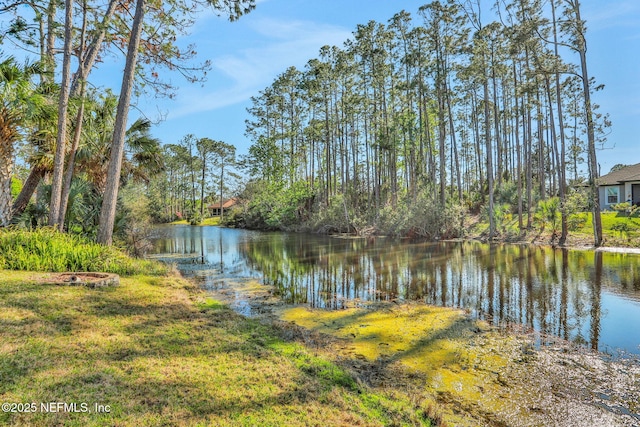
{"left": 0, "top": 228, "right": 167, "bottom": 275}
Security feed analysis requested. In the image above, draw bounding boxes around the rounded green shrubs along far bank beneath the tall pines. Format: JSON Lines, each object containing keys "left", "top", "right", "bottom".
{"left": 239, "top": 181, "right": 465, "bottom": 239}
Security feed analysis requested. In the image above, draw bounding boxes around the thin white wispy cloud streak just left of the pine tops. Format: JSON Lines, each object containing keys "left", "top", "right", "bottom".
{"left": 165, "top": 19, "right": 351, "bottom": 118}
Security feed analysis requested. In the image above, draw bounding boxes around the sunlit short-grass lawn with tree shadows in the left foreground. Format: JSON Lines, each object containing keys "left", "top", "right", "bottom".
{"left": 0, "top": 270, "right": 429, "bottom": 426}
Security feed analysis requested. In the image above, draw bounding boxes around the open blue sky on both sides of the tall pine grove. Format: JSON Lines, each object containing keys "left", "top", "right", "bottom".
{"left": 91, "top": 0, "right": 640, "bottom": 173}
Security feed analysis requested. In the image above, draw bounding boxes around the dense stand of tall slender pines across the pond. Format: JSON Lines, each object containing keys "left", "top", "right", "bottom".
{"left": 244, "top": 0, "right": 608, "bottom": 245}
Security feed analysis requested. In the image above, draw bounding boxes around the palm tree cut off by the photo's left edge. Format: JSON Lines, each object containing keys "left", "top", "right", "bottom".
{"left": 0, "top": 57, "right": 45, "bottom": 227}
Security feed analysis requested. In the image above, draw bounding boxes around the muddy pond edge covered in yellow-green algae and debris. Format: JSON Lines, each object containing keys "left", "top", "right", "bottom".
{"left": 205, "top": 280, "right": 640, "bottom": 427}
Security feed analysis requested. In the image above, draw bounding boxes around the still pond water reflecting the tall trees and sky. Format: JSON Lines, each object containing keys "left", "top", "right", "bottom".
{"left": 149, "top": 226, "right": 640, "bottom": 355}
